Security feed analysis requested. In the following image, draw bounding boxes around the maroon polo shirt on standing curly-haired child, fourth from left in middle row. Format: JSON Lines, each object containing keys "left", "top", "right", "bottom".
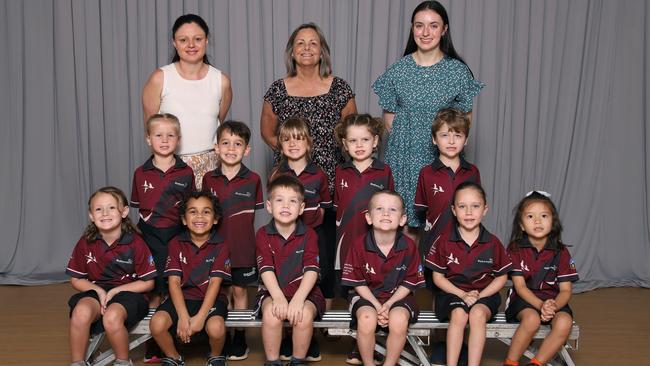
{"left": 334, "top": 159, "right": 395, "bottom": 269}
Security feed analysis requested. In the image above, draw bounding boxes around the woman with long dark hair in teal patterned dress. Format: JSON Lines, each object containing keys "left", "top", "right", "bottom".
{"left": 372, "top": 1, "right": 484, "bottom": 232}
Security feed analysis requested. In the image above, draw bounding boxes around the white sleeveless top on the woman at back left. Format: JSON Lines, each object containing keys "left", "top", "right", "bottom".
{"left": 160, "top": 63, "right": 221, "bottom": 155}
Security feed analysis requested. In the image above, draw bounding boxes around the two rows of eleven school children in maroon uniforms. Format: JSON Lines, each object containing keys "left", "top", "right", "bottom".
{"left": 66, "top": 109, "right": 578, "bottom": 366}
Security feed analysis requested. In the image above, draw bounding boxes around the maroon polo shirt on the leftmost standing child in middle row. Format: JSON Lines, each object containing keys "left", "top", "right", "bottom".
{"left": 131, "top": 156, "right": 194, "bottom": 228}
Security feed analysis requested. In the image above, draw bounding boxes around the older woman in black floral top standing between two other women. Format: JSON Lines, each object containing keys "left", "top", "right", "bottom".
{"left": 260, "top": 23, "right": 357, "bottom": 194}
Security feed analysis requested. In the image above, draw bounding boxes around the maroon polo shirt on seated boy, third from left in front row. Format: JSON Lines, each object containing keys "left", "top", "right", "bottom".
{"left": 256, "top": 220, "right": 320, "bottom": 298}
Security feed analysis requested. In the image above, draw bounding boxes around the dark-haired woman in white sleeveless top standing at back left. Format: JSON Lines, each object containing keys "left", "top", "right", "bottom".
{"left": 142, "top": 14, "right": 232, "bottom": 189}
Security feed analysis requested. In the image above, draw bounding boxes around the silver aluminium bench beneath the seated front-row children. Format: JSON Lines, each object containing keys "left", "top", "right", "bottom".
{"left": 86, "top": 309, "right": 580, "bottom": 366}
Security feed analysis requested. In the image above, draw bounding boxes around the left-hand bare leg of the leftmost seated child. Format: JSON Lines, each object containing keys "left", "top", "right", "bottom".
{"left": 70, "top": 297, "right": 101, "bottom": 362}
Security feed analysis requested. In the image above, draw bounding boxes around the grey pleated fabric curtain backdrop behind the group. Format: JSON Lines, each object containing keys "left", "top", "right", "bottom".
{"left": 0, "top": 0, "right": 650, "bottom": 290}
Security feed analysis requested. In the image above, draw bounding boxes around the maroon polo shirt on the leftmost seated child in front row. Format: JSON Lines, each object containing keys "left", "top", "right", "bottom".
{"left": 65, "top": 233, "right": 156, "bottom": 290}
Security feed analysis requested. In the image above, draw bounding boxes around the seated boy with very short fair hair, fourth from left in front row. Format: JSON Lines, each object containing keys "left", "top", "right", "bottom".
{"left": 341, "top": 190, "right": 424, "bottom": 365}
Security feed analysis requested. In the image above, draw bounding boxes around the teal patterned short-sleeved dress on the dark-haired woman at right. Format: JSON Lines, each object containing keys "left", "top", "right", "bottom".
{"left": 372, "top": 54, "right": 485, "bottom": 226}
